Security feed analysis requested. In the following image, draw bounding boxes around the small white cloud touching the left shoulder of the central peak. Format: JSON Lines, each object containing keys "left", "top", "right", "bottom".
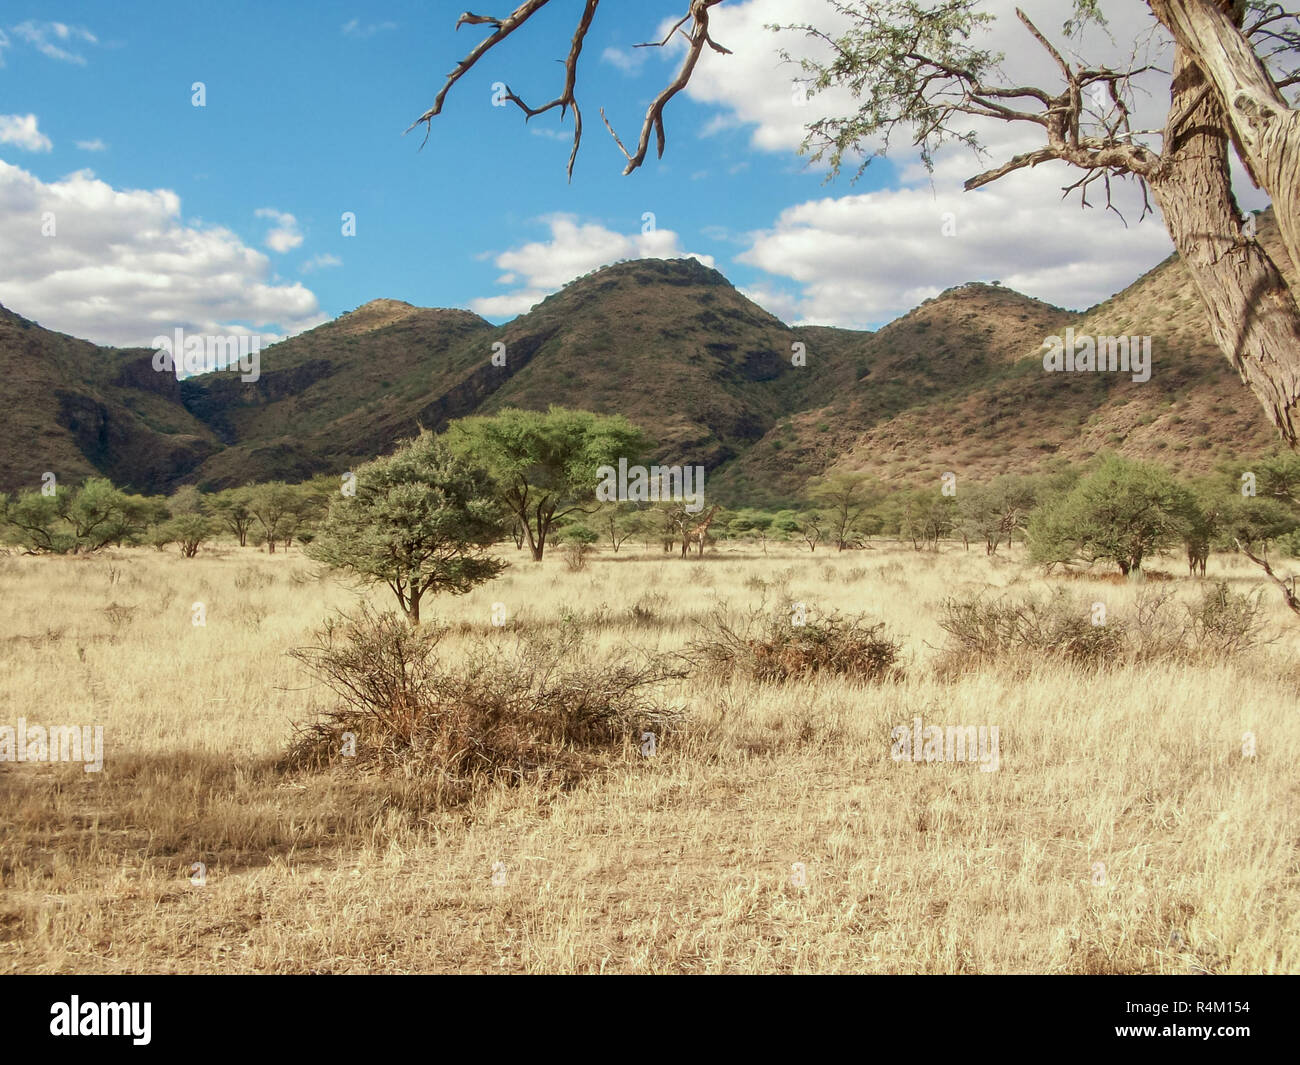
{"left": 469, "top": 215, "right": 714, "bottom": 317}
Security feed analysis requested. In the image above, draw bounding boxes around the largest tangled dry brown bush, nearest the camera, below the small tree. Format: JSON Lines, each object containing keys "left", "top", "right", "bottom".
{"left": 286, "top": 606, "right": 685, "bottom": 802}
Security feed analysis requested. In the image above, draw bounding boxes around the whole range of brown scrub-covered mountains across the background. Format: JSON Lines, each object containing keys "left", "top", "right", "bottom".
{"left": 0, "top": 223, "right": 1290, "bottom": 505}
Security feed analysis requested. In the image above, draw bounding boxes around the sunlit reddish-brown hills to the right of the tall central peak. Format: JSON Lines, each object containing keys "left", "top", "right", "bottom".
{"left": 710, "top": 212, "right": 1294, "bottom": 505}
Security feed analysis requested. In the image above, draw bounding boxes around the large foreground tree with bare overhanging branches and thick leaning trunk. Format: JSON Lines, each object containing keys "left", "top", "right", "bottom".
{"left": 411, "top": 0, "right": 1300, "bottom": 446}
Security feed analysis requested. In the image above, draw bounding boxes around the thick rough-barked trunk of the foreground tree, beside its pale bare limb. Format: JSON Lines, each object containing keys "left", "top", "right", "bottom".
{"left": 1149, "top": 48, "right": 1300, "bottom": 445}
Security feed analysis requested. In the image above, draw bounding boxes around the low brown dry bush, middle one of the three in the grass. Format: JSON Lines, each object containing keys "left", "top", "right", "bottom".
{"left": 684, "top": 606, "right": 902, "bottom": 681}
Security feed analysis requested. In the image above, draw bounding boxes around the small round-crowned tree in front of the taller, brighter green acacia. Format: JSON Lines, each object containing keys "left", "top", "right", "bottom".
{"left": 307, "top": 432, "right": 507, "bottom": 624}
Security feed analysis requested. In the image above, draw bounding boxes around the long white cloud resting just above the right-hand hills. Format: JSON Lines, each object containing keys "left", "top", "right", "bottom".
{"left": 737, "top": 150, "right": 1173, "bottom": 328}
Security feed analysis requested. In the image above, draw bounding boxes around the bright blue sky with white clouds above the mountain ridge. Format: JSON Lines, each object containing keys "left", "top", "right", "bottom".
{"left": 0, "top": 0, "right": 1248, "bottom": 343}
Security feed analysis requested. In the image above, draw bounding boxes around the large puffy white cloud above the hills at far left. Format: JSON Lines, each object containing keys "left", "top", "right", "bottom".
{"left": 0, "top": 161, "right": 326, "bottom": 346}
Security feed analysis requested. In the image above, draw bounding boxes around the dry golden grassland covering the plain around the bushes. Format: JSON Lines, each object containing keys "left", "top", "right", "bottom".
{"left": 0, "top": 544, "right": 1300, "bottom": 973}
